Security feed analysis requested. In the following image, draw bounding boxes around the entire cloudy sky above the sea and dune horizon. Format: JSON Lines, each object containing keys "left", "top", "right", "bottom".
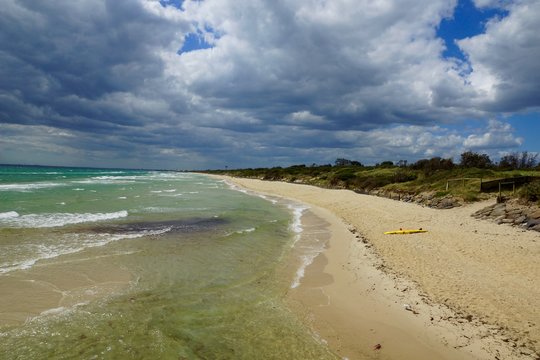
{"left": 0, "top": 0, "right": 540, "bottom": 170}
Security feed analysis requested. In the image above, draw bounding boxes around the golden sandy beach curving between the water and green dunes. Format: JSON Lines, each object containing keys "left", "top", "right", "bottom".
{"left": 221, "top": 178, "right": 540, "bottom": 359}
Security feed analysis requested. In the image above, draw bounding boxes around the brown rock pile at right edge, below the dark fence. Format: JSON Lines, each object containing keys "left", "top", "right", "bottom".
{"left": 472, "top": 201, "right": 540, "bottom": 231}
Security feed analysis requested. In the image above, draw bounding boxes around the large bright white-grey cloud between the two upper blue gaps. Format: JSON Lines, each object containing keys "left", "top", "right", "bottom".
{"left": 169, "top": 0, "right": 461, "bottom": 129}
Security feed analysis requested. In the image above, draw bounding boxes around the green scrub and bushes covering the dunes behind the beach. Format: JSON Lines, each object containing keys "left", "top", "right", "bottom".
{"left": 204, "top": 151, "right": 540, "bottom": 202}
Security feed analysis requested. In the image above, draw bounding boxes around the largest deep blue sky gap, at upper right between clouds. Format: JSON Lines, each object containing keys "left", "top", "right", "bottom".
{"left": 437, "top": 0, "right": 508, "bottom": 61}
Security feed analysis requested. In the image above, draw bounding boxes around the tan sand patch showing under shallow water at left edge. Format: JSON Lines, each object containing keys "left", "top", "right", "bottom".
{"left": 0, "top": 249, "right": 132, "bottom": 328}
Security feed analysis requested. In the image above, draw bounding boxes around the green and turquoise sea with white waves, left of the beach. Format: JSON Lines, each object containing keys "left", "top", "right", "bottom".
{"left": 0, "top": 165, "right": 337, "bottom": 359}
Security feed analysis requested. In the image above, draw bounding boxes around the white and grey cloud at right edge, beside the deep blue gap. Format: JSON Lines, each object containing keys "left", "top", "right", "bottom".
{"left": 458, "top": 0, "right": 540, "bottom": 112}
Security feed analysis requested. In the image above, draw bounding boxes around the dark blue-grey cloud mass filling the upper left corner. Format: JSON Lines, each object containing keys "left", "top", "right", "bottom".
{"left": 0, "top": 0, "right": 189, "bottom": 130}
